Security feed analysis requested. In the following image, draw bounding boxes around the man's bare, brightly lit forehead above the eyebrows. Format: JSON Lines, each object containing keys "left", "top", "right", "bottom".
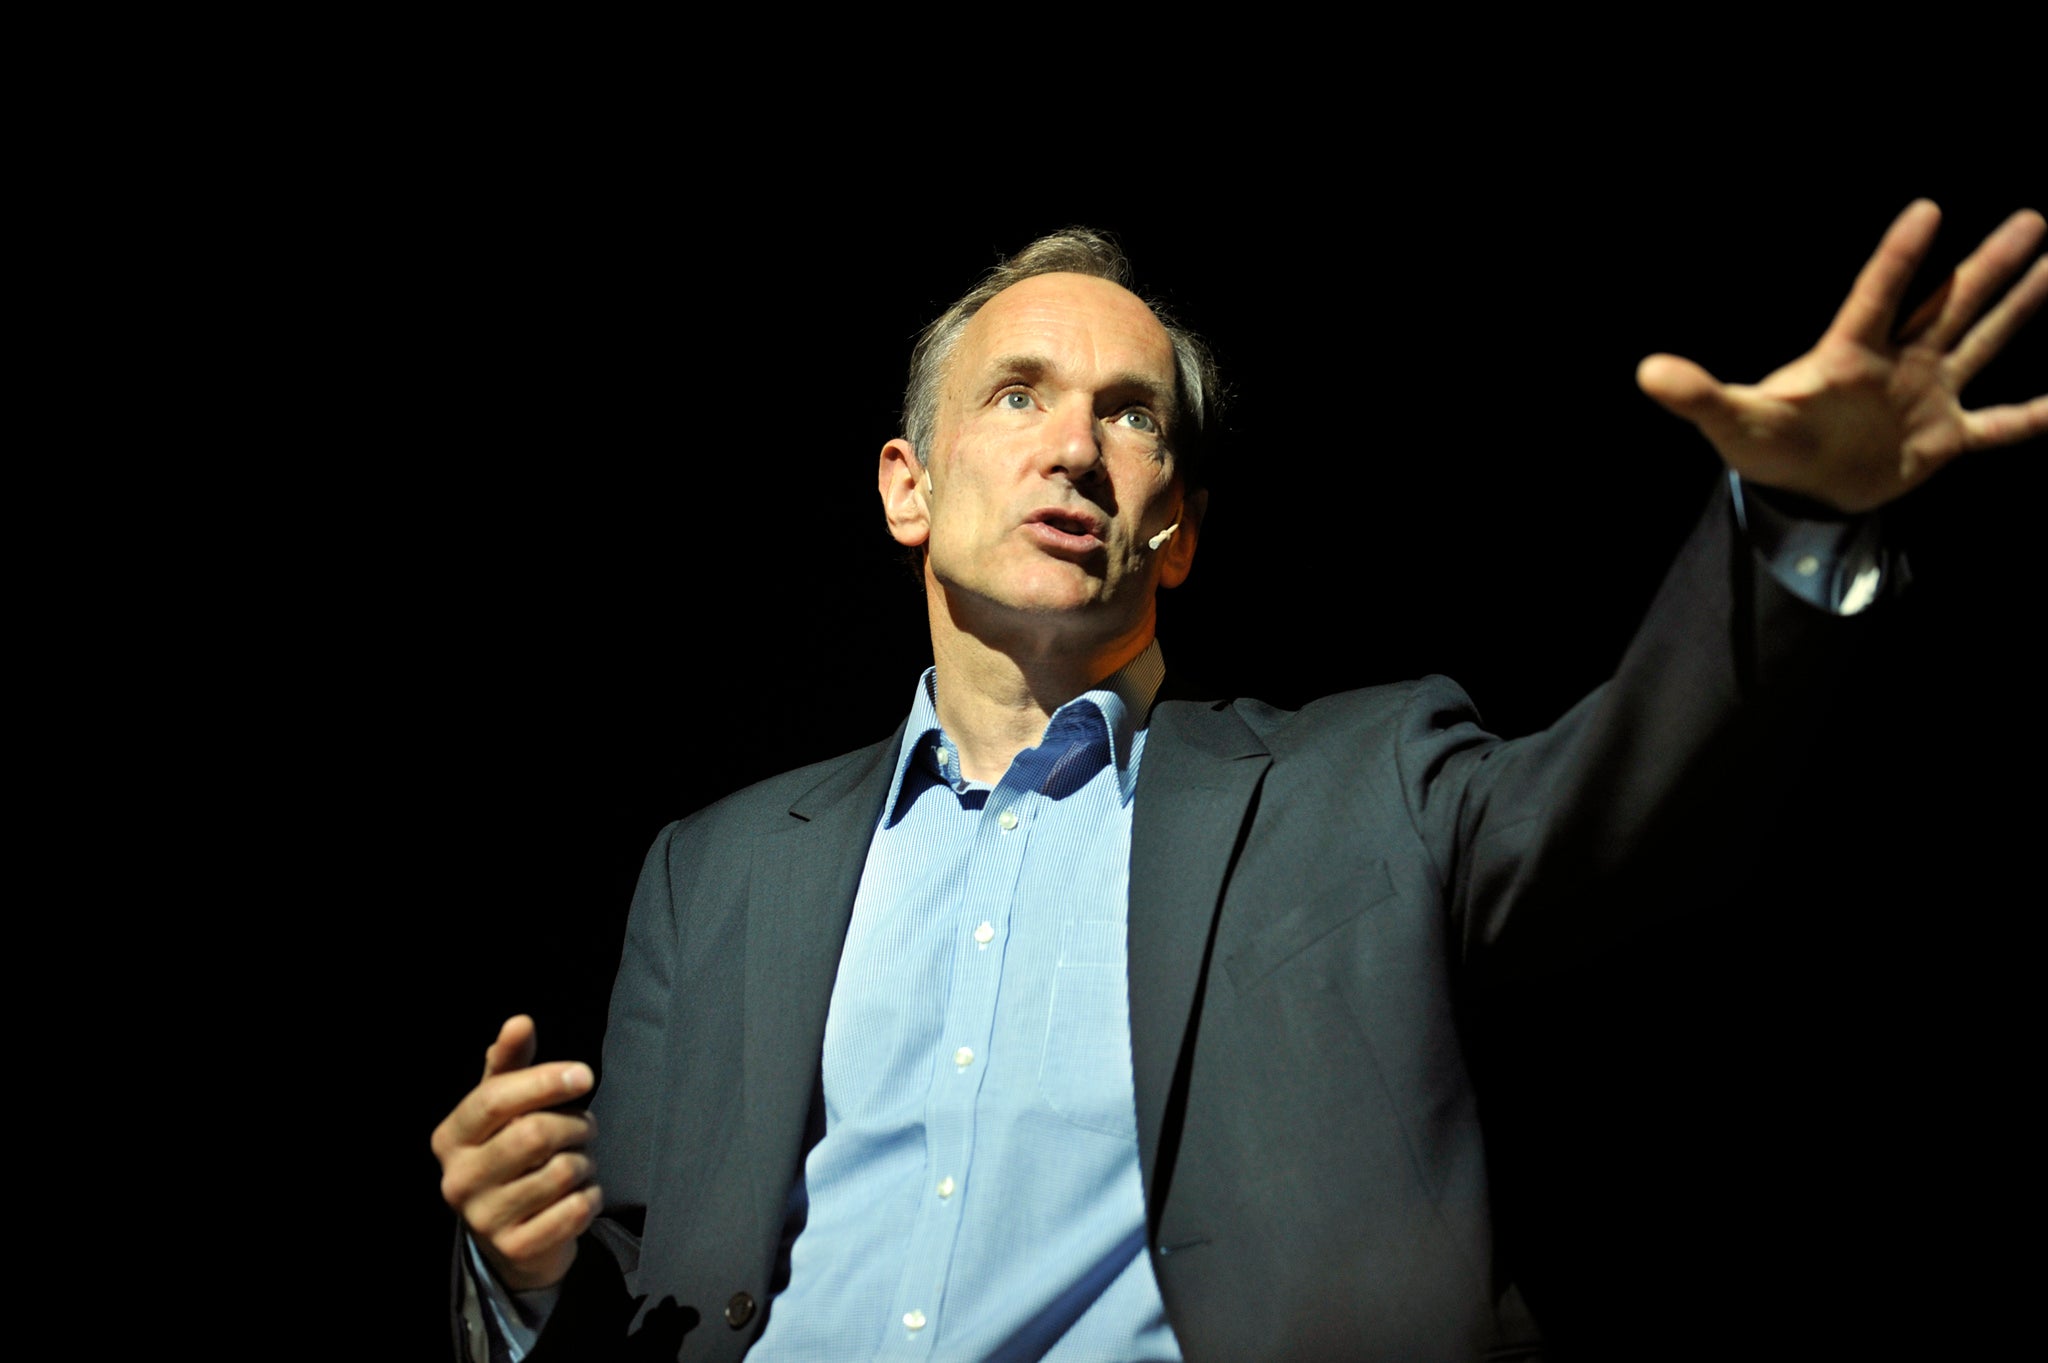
{"left": 954, "top": 274, "right": 1174, "bottom": 389}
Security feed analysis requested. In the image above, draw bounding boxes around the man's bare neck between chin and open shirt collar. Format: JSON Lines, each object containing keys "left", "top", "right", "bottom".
{"left": 930, "top": 589, "right": 1155, "bottom": 782}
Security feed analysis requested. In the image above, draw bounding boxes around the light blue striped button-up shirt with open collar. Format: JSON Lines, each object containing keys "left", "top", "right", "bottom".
{"left": 750, "top": 643, "right": 1180, "bottom": 1361}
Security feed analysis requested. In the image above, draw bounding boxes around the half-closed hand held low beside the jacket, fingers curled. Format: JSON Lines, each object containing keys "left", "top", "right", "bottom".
{"left": 434, "top": 1013, "right": 604, "bottom": 1291}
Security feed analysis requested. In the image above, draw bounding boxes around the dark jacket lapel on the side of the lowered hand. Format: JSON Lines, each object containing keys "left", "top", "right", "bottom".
{"left": 741, "top": 729, "right": 903, "bottom": 1216}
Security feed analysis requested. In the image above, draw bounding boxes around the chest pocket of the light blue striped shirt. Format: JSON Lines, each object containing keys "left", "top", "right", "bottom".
{"left": 1038, "top": 919, "right": 1139, "bottom": 1140}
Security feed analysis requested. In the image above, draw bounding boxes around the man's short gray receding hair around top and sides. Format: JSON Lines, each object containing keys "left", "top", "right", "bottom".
{"left": 903, "top": 227, "right": 1223, "bottom": 491}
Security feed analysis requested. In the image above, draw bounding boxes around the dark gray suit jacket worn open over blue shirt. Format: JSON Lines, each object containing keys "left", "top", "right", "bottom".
{"left": 507, "top": 482, "right": 1849, "bottom": 1363}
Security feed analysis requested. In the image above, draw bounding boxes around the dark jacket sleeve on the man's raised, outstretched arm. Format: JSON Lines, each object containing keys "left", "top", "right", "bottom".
{"left": 1399, "top": 472, "right": 1864, "bottom": 972}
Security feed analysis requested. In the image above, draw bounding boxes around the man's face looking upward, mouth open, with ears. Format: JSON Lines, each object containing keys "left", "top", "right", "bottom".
{"left": 883, "top": 274, "right": 1194, "bottom": 641}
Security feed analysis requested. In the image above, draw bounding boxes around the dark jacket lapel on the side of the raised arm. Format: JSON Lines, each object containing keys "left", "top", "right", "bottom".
{"left": 1128, "top": 702, "right": 1272, "bottom": 1228}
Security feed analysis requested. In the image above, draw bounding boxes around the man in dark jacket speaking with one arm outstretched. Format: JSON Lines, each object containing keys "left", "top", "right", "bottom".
{"left": 434, "top": 203, "right": 2048, "bottom": 1359}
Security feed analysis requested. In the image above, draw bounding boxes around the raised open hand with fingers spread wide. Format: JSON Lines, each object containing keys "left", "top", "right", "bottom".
{"left": 1636, "top": 199, "right": 2048, "bottom": 512}
